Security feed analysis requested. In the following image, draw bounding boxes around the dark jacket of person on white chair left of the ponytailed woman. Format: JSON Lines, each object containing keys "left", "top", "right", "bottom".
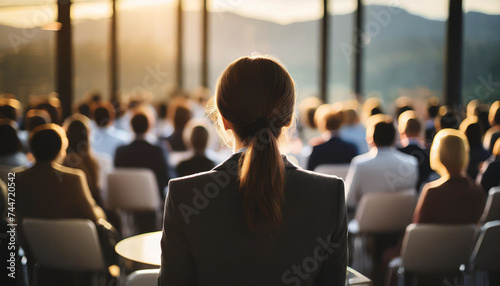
{"left": 115, "top": 140, "right": 170, "bottom": 198}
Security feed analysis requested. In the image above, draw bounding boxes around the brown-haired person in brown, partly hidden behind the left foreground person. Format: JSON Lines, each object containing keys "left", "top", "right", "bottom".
{"left": 63, "top": 114, "right": 103, "bottom": 207}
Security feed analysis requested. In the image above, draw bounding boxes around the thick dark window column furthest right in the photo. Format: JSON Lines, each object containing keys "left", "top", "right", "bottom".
{"left": 444, "top": 0, "right": 463, "bottom": 107}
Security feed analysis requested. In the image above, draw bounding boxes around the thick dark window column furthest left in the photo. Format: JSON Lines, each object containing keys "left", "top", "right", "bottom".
{"left": 56, "top": 0, "right": 73, "bottom": 118}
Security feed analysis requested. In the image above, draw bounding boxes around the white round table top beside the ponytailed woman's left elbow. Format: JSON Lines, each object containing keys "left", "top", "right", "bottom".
{"left": 115, "top": 231, "right": 161, "bottom": 266}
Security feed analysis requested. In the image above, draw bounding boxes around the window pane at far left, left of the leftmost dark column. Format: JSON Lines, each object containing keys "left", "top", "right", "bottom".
{"left": 0, "top": 1, "right": 57, "bottom": 102}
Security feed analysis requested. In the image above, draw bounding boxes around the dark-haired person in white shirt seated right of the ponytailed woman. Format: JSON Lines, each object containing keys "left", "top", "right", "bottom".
{"left": 346, "top": 114, "right": 418, "bottom": 211}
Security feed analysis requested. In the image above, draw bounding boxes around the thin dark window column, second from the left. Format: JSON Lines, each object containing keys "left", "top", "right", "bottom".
{"left": 109, "top": 0, "right": 118, "bottom": 102}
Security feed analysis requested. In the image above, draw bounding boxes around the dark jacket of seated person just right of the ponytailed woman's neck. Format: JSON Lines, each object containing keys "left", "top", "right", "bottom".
{"left": 307, "top": 136, "right": 358, "bottom": 171}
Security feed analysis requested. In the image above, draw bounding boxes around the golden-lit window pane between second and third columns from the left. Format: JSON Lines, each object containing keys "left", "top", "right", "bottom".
{"left": 117, "top": 0, "right": 177, "bottom": 97}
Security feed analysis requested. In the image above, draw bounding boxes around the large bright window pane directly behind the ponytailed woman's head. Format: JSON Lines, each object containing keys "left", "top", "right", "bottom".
{"left": 209, "top": 0, "right": 323, "bottom": 101}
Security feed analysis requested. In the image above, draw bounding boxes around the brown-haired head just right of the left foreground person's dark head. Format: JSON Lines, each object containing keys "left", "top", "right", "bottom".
{"left": 63, "top": 114, "right": 90, "bottom": 156}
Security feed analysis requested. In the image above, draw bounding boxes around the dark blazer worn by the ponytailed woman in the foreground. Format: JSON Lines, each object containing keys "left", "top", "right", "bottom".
{"left": 159, "top": 153, "right": 347, "bottom": 286}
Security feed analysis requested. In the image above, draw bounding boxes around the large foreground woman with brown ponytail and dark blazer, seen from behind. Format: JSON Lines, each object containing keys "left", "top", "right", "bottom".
{"left": 158, "top": 56, "right": 347, "bottom": 286}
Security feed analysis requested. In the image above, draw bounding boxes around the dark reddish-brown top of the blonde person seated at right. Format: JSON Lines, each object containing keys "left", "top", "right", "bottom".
{"left": 413, "top": 176, "right": 486, "bottom": 224}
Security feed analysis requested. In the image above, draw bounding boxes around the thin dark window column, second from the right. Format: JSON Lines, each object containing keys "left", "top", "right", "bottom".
{"left": 353, "top": 0, "right": 364, "bottom": 99}
